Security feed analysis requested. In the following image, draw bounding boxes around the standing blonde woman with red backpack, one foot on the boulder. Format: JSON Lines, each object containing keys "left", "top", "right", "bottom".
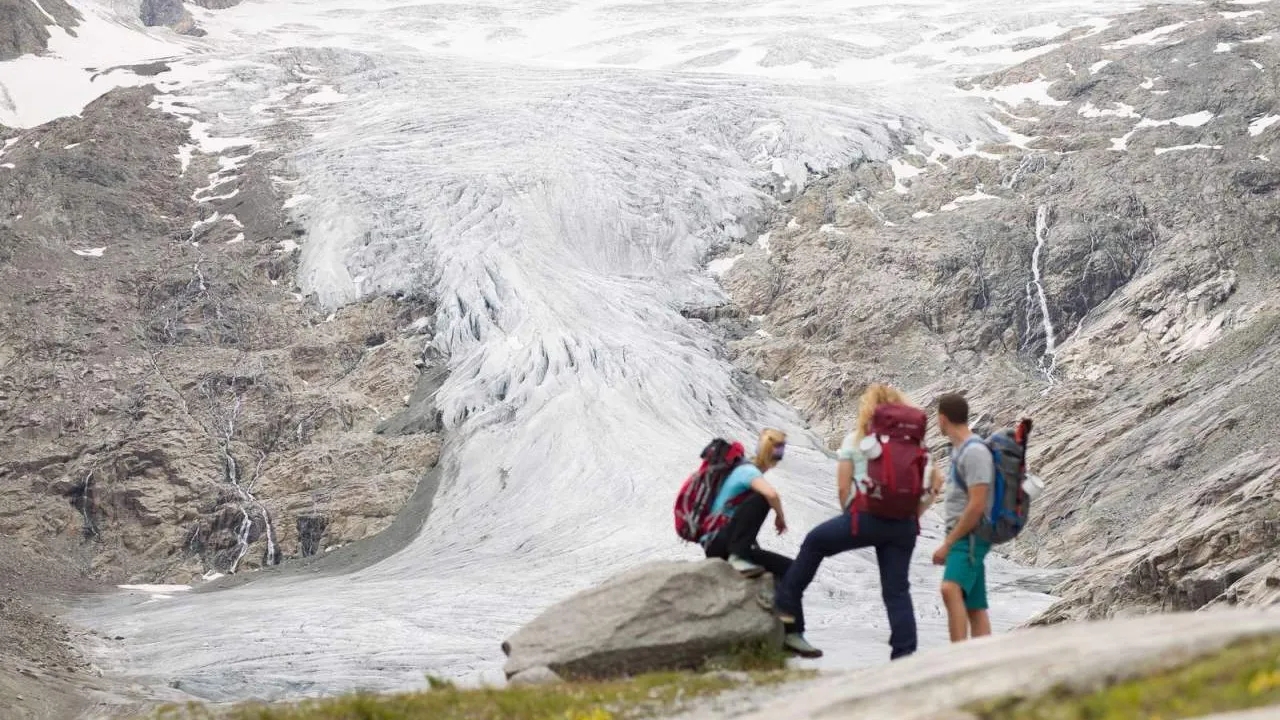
{"left": 774, "top": 383, "right": 942, "bottom": 660}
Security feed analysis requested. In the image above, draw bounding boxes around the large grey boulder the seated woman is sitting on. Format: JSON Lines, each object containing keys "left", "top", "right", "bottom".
{"left": 502, "top": 560, "right": 782, "bottom": 679}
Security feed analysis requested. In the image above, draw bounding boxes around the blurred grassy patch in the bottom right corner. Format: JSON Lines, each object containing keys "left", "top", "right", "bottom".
{"left": 966, "top": 638, "right": 1280, "bottom": 720}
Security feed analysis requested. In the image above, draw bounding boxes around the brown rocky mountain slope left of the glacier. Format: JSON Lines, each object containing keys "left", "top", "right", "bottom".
{"left": 0, "top": 82, "right": 439, "bottom": 583}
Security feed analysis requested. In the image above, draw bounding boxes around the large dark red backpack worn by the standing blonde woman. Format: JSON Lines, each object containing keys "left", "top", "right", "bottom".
{"left": 854, "top": 405, "right": 929, "bottom": 520}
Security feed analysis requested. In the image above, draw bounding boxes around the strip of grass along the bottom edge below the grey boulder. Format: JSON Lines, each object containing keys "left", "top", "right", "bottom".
{"left": 151, "top": 648, "right": 808, "bottom": 720}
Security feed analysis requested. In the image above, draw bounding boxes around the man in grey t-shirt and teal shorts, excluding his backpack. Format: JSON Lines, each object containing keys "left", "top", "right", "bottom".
{"left": 933, "top": 393, "right": 998, "bottom": 642}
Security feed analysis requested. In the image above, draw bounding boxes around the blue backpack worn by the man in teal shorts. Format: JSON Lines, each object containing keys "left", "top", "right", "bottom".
{"left": 951, "top": 419, "right": 1032, "bottom": 544}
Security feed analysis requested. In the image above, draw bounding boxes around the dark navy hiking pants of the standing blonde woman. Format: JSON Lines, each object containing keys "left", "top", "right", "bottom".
{"left": 774, "top": 512, "right": 916, "bottom": 659}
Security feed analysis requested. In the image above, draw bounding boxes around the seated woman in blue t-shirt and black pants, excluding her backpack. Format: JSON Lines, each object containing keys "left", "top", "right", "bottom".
{"left": 701, "top": 428, "right": 791, "bottom": 580}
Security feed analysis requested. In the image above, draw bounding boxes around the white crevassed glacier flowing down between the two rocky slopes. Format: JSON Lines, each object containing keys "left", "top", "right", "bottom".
{"left": 0, "top": 0, "right": 1177, "bottom": 701}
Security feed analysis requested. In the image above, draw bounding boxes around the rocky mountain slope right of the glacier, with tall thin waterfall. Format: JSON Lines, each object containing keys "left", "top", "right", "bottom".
{"left": 719, "top": 3, "right": 1280, "bottom": 621}
